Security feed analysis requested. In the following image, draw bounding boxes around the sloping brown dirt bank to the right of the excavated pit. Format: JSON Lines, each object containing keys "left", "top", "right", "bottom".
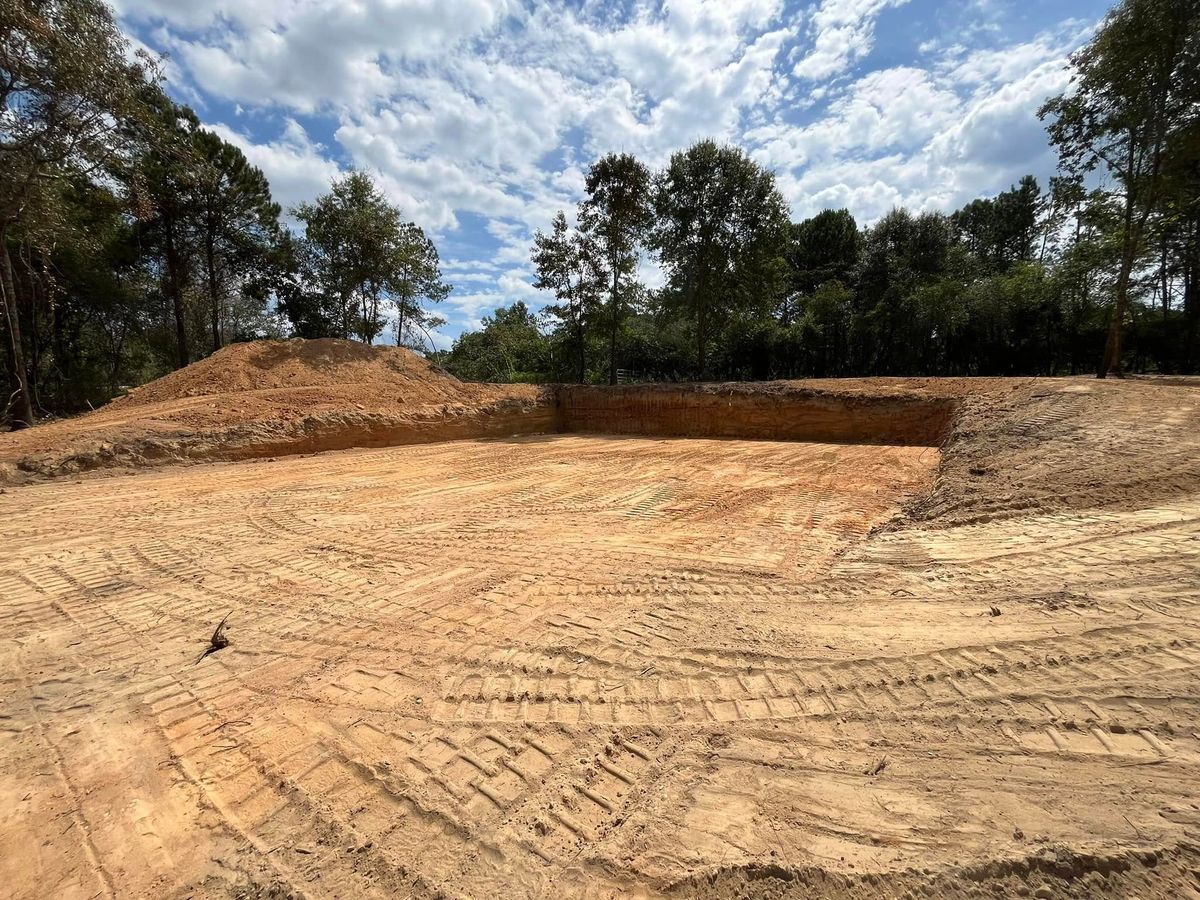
{"left": 911, "top": 378, "right": 1200, "bottom": 524}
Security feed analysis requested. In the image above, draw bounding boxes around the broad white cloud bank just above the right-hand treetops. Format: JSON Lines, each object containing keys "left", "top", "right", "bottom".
{"left": 746, "top": 28, "right": 1082, "bottom": 222}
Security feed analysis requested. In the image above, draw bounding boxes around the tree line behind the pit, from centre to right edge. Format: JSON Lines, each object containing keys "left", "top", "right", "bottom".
{"left": 439, "top": 0, "right": 1200, "bottom": 383}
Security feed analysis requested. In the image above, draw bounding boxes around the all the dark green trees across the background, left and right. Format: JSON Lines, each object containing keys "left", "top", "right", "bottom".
{"left": 0, "top": 0, "right": 1200, "bottom": 427}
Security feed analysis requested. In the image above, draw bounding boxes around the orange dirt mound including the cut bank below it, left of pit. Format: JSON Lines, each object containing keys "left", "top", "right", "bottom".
{"left": 0, "top": 340, "right": 554, "bottom": 484}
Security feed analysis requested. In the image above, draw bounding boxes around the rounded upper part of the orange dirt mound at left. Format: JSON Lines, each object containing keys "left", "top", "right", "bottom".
{"left": 110, "top": 338, "right": 462, "bottom": 409}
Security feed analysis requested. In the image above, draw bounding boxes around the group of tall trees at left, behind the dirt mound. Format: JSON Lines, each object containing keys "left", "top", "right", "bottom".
{"left": 0, "top": 0, "right": 450, "bottom": 427}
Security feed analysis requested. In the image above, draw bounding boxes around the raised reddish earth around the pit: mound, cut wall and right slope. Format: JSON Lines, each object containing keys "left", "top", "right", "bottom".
{"left": 0, "top": 340, "right": 1200, "bottom": 532}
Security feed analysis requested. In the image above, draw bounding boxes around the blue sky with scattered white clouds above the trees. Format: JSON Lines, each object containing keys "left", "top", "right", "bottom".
{"left": 115, "top": 0, "right": 1110, "bottom": 347}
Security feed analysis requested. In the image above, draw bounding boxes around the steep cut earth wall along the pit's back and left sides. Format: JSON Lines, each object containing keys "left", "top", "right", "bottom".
{"left": 0, "top": 384, "right": 959, "bottom": 484}
